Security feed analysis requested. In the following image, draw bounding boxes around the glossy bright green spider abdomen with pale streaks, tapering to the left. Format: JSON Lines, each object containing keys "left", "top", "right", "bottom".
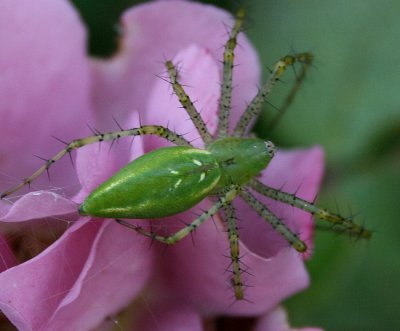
{"left": 79, "top": 146, "right": 221, "bottom": 218}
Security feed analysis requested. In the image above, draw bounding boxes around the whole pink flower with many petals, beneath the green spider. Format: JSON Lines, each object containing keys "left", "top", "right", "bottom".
{"left": 0, "top": 0, "right": 323, "bottom": 330}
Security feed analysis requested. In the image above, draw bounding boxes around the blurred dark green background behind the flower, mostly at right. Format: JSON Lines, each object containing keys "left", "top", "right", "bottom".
{"left": 70, "top": 0, "right": 400, "bottom": 331}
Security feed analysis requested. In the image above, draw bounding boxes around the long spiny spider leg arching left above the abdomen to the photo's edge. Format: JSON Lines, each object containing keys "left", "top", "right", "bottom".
{"left": 0, "top": 125, "right": 192, "bottom": 199}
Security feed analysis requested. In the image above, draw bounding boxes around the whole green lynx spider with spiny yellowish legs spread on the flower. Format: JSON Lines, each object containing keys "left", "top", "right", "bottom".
{"left": 0, "top": 11, "right": 371, "bottom": 300}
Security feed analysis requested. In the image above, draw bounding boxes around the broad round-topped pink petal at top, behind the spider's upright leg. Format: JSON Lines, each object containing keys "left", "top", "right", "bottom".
{"left": 93, "top": 0, "right": 260, "bottom": 130}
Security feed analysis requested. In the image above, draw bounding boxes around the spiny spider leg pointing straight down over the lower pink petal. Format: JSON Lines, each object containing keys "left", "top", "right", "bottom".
{"left": 224, "top": 203, "right": 244, "bottom": 300}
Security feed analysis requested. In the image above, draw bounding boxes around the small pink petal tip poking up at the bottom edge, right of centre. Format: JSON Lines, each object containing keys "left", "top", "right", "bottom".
{"left": 254, "top": 307, "right": 322, "bottom": 331}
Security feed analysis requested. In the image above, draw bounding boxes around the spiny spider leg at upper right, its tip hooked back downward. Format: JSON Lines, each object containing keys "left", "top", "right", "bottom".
{"left": 233, "top": 53, "right": 313, "bottom": 137}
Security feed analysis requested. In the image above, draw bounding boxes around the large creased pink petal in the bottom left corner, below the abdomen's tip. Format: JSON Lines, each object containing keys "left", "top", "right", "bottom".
{"left": 0, "top": 221, "right": 152, "bottom": 330}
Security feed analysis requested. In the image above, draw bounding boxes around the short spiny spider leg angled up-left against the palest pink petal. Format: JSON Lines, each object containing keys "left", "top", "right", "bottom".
{"left": 165, "top": 61, "right": 212, "bottom": 145}
